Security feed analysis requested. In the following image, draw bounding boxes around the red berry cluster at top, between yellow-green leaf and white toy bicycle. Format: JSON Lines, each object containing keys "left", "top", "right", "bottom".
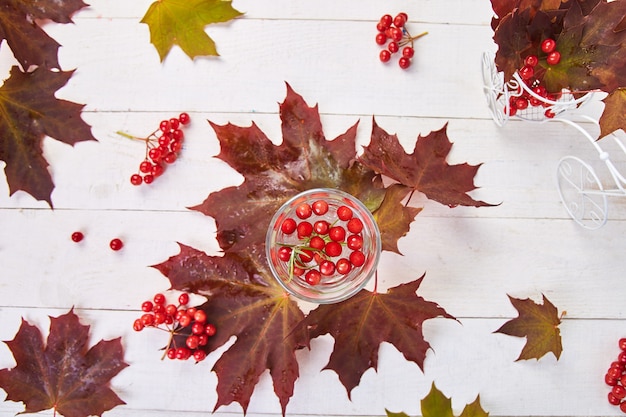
{"left": 376, "top": 12, "right": 427, "bottom": 69}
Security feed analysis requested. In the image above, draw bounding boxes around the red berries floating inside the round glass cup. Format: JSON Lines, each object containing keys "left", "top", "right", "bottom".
{"left": 278, "top": 200, "right": 366, "bottom": 285}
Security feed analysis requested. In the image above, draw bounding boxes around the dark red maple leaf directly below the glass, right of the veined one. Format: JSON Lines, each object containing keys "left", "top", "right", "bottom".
{"left": 304, "top": 275, "right": 454, "bottom": 397}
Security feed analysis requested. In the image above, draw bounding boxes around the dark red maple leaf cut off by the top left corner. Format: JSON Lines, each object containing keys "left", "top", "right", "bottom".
{"left": 0, "top": 0, "right": 87, "bottom": 71}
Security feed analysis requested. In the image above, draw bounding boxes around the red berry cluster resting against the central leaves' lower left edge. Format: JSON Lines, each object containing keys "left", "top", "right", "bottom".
{"left": 133, "top": 293, "right": 217, "bottom": 362}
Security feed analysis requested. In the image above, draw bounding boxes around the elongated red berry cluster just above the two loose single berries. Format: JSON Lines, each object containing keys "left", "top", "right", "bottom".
{"left": 124, "top": 113, "right": 190, "bottom": 185}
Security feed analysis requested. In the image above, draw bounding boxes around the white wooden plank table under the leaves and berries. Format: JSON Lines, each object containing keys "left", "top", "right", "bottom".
{"left": 0, "top": 0, "right": 626, "bottom": 417}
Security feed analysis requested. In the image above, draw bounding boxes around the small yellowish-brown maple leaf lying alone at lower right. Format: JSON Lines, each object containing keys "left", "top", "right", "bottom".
{"left": 495, "top": 295, "right": 563, "bottom": 361}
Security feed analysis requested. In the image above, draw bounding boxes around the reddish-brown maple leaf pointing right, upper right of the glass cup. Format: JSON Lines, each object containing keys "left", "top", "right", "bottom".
{"left": 360, "top": 121, "right": 491, "bottom": 207}
